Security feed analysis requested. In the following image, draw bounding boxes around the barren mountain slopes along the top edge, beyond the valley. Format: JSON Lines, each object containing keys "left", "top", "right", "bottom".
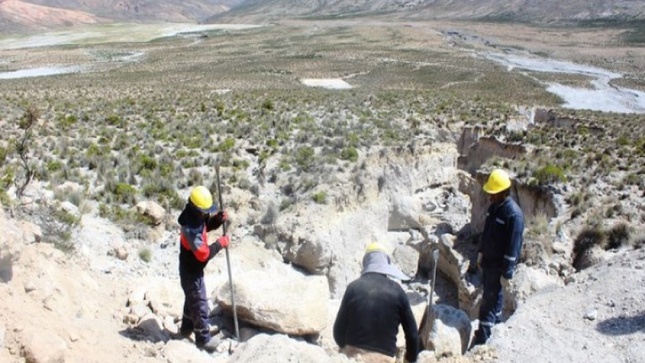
{"left": 0, "top": 0, "right": 645, "bottom": 31}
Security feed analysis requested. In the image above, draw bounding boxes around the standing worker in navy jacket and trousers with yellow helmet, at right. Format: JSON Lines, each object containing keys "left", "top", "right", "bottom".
{"left": 472, "top": 169, "right": 524, "bottom": 346}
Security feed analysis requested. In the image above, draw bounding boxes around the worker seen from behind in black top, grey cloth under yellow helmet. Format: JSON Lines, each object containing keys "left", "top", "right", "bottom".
{"left": 334, "top": 243, "right": 419, "bottom": 363}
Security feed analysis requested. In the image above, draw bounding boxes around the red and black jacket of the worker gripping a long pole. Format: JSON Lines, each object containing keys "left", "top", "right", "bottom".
{"left": 177, "top": 202, "right": 222, "bottom": 276}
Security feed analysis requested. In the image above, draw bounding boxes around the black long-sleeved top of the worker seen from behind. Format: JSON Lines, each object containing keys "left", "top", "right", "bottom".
{"left": 334, "top": 272, "right": 419, "bottom": 362}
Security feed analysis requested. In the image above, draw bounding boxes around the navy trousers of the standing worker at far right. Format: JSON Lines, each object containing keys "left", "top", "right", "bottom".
{"left": 473, "top": 269, "right": 504, "bottom": 344}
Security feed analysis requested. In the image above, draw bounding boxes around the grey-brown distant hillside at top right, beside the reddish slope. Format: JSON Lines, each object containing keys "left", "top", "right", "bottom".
{"left": 209, "top": 0, "right": 645, "bottom": 22}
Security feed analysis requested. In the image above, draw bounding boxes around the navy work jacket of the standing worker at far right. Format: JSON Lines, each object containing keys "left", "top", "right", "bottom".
{"left": 479, "top": 196, "right": 524, "bottom": 279}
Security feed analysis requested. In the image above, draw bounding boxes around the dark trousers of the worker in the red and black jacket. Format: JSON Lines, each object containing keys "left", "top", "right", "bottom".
{"left": 179, "top": 272, "right": 211, "bottom": 345}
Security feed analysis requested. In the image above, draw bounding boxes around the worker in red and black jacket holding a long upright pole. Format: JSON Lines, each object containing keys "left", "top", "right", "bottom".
{"left": 178, "top": 186, "right": 229, "bottom": 352}
